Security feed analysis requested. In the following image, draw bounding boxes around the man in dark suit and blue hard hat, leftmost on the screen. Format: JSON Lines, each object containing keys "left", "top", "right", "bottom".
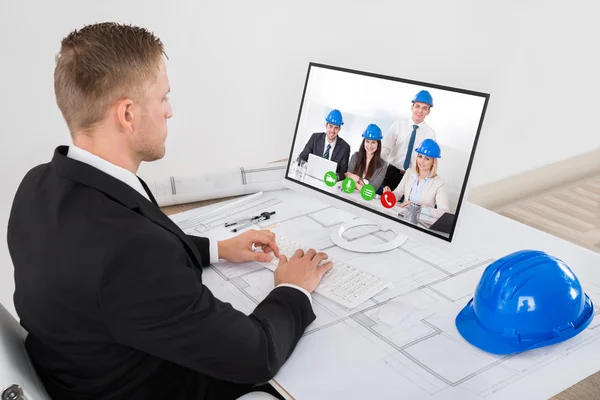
{"left": 298, "top": 110, "right": 350, "bottom": 181}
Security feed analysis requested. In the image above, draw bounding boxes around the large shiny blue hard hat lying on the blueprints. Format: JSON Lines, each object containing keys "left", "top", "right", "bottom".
{"left": 455, "top": 250, "right": 594, "bottom": 354}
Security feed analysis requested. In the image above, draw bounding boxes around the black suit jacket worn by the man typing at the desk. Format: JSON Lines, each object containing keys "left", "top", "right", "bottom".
{"left": 8, "top": 146, "right": 315, "bottom": 400}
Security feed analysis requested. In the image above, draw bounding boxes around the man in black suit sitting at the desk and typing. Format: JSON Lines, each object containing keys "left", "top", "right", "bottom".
{"left": 8, "top": 23, "right": 331, "bottom": 400}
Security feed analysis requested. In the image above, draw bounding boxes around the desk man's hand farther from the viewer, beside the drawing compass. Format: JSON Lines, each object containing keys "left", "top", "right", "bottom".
{"left": 218, "top": 229, "right": 279, "bottom": 263}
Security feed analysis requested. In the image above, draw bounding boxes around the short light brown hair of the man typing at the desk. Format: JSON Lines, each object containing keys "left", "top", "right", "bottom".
{"left": 54, "top": 22, "right": 166, "bottom": 134}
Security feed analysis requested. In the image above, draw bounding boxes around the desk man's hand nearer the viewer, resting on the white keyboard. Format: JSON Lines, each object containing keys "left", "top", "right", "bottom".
{"left": 275, "top": 249, "right": 333, "bottom": 293}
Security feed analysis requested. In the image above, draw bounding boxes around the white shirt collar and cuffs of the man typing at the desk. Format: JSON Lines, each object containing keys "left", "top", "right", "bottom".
{"left": 67, "top": 145, "right": 312, "bottom": 305}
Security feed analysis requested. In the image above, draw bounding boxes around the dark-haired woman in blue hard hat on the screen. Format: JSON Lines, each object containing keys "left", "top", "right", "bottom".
{"left": 346, "top": 124, "right": 387, "bottom": 190}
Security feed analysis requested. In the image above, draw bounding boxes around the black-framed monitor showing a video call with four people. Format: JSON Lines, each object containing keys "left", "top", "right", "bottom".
{"left": 286, "top": 63, "right": 489, "bottom": 241}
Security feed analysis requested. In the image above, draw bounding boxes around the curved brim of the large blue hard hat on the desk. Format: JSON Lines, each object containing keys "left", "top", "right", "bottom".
{"left": 455, "top": 295, "right": 594, "bottom": 355}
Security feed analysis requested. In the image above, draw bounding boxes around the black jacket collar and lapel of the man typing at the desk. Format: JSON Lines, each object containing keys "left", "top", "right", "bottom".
{"left": 51, "top": 146, "right": 202, "bottom": 266}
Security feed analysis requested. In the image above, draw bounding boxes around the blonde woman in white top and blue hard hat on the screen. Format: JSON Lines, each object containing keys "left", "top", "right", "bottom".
{"left": 383, "top": 139, "right": 450, "bottom": 217}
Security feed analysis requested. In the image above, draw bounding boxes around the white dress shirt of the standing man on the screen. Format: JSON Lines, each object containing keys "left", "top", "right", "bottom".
{"left": 381, "top": 118, "right": 436, "bottom": 171}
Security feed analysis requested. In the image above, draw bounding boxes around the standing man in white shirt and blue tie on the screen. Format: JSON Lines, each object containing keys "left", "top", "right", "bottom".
{"left": 378, "top": 90, "right": 436, "bottom": 193}
